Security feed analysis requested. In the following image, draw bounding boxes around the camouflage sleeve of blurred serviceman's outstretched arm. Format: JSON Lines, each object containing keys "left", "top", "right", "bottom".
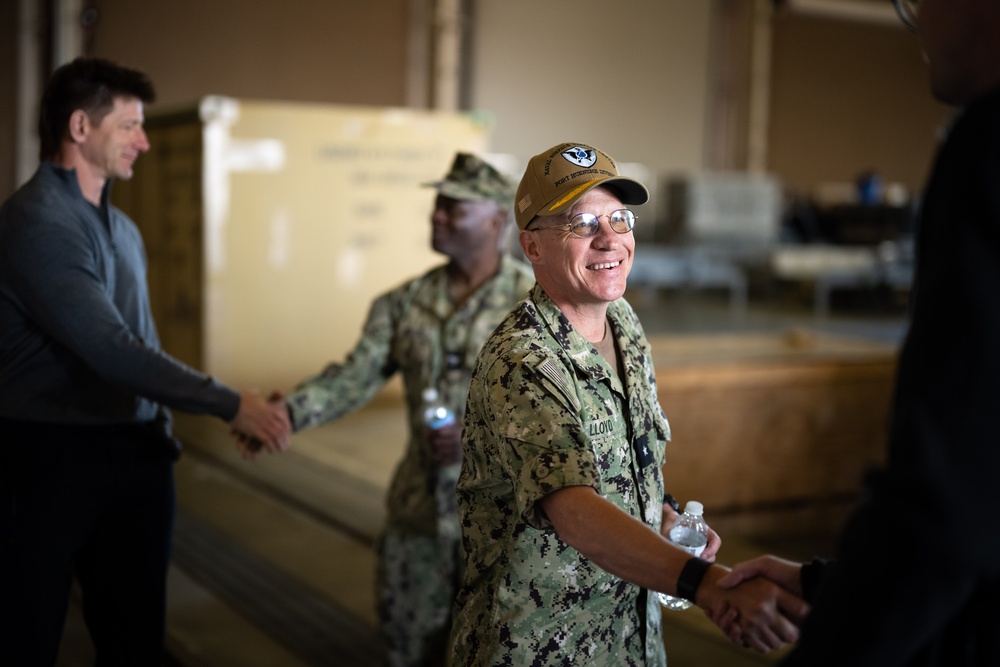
{"left": 288, "top": 294, "right": 398, "bottom": 431}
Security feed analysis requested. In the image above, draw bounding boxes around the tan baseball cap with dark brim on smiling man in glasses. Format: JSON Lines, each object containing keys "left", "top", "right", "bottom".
{"left": 514, "top": 143, "right": 649, "bottom": 229}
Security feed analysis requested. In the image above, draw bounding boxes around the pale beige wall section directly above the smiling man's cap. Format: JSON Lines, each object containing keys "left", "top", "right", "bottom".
{"left": 472, "top": 0, "right": 712, "bottom": 180}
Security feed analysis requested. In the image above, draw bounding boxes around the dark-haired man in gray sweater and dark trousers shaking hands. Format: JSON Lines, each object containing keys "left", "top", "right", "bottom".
{"left": 0, "top": 59, "right": 289, "bottom": 667}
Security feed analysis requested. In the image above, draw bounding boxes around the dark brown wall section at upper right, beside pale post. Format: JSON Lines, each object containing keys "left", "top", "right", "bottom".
{"left": 769, "top": 14, "right": 950, "bottom": 192}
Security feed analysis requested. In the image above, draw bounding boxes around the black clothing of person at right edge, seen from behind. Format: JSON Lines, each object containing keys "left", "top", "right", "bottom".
{"left": 783, "top": 95, "right": 1000, "bottom": 667}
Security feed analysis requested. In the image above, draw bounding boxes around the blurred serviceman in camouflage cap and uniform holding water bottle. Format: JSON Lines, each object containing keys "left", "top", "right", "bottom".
{"left": 287, "top": 153, "right": 534, "bottom": 667}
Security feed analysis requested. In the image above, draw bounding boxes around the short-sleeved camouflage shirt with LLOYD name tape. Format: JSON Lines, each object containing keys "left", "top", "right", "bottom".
{"left": 451, "top": 285, "right": 670, "bottom": 667}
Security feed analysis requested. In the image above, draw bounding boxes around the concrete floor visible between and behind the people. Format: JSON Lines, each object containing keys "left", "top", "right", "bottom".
{"left": 58, "top": 294, "right": 905, "bottom": 667}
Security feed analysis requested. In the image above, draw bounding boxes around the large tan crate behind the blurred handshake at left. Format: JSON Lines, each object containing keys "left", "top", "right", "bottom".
{"left": 113, "top": 97, "right": 489, "bottom": 391}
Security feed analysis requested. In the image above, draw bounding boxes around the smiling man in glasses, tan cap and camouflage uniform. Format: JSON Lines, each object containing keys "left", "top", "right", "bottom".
{"left": 450, "top": 144, "right": 804, "bottom": 667}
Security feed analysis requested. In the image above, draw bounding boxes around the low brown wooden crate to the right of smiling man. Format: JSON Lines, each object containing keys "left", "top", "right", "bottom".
{"left": 652, "top": 331, "right": 896, "bottom": 536}
